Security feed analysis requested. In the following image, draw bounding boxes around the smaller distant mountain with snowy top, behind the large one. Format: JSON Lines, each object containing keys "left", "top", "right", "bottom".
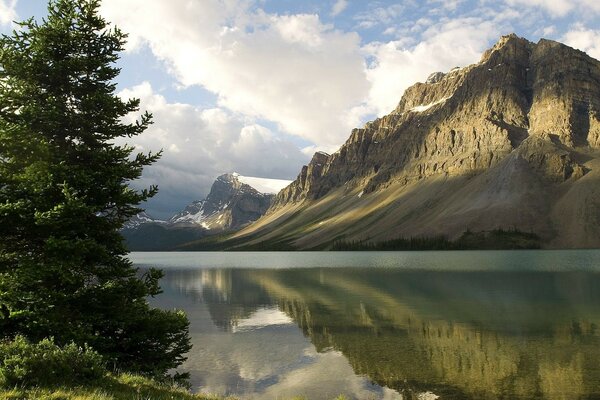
{"left": 122, "top": 173, "right": 288, "bottom": 251}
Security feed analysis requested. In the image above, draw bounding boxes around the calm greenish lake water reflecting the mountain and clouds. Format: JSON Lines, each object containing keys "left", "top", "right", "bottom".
{"left": 130, "top": 250, "right": 600, "bottom": 400}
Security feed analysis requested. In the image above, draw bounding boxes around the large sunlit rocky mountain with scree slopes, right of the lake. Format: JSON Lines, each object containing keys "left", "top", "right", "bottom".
{"left": 224, "top": 34, "right": 600, "bottom": 249}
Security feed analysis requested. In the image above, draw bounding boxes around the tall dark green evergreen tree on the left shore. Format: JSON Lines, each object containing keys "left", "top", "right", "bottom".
{"left": 0, "top": 0, "right": 190, "bottom": 374}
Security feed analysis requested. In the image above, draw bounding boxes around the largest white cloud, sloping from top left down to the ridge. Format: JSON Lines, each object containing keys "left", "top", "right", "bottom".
{"left": 103, "top": 0, "right": 368, "bottom": 146}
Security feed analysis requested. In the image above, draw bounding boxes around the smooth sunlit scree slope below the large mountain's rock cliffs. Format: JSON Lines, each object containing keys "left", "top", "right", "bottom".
{"left": 234, "top": 143, "right": 600, "bottom": 248}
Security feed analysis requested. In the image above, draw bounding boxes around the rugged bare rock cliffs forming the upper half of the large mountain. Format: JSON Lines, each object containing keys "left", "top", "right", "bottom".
{"left": 274, "top": 35, "right": 600, "bottom": 207}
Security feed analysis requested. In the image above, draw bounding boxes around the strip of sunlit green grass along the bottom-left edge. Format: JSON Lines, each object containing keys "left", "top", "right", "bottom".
{"left": 0, "top": 374, "right": 223, "bottom": 400}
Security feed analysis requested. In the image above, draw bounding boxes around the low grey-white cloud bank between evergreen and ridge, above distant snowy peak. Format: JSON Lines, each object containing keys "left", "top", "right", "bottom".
{"left": 120, "top": 82, "right": 308, "bottom": 217}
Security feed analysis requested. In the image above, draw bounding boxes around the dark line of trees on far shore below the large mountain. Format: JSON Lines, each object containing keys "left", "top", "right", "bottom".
{"left": 331, "top": 228, "right": 541, "bottom": 251}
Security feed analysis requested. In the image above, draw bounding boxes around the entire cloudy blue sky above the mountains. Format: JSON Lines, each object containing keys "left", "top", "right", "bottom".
{"left": 0, "top": 0, "right": 600, "bottom": 218}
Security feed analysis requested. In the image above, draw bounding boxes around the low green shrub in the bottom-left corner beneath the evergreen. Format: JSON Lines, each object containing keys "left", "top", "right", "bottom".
{"left": 0, "top": 336, "right": 107, "bottom": 387}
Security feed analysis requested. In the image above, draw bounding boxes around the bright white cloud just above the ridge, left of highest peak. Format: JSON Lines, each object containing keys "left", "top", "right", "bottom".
{"left": 364, "top": 19, "right": 500, "bottom": 116}
